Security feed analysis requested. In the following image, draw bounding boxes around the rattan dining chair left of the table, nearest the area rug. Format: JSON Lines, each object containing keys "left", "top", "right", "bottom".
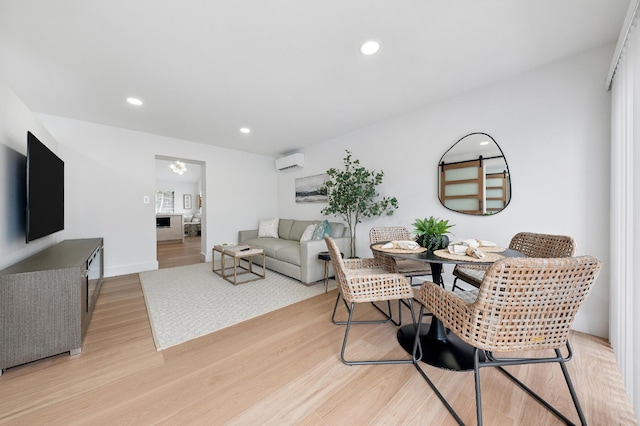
{"left": 324, "top": 236, "right": 415, "bottom": 365}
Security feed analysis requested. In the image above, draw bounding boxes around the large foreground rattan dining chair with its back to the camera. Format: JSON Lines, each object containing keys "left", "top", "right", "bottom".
{"left": 414, "top": 256, "right": 601, "bottom": 425}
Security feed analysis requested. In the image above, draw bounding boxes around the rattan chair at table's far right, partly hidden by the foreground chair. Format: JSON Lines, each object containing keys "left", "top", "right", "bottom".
{"left": 452, "top": 232, "right": 576, "bottom": 290}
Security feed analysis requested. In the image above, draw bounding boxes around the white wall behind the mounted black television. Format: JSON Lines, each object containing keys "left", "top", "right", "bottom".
{"left": 0, "top": 78, "right": 65, "bottom": 269}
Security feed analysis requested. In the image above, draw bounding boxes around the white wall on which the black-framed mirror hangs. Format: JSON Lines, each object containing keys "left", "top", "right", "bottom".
{"left": 278, "top": 45, "right": 614, "bottom": 337}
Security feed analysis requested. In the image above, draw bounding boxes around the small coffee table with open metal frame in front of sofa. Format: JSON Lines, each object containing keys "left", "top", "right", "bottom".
{"left": 211, "top": 245, "right": 267, "bottom": 285}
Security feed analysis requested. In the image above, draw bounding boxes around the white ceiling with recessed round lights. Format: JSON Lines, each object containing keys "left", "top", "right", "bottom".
{"left": 0, "top": 0, "right": 629, "bottom": 157}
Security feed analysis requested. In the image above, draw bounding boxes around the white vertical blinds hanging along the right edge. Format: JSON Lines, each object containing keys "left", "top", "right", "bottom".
{"left": 607, "top": 0, "right": 640, "bottom": 416}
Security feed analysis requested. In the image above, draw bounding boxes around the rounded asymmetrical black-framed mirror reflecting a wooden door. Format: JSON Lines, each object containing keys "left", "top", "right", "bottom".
{"left": 438, "top": 133, "right": 511, "bottom": 215}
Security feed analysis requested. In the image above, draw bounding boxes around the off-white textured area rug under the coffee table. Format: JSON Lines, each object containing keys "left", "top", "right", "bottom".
{"left": 139, "top": 262, "right": 335, "bottom": 351}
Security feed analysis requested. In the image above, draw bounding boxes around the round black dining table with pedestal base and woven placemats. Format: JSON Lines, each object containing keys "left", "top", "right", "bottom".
{"left": 371, "top": 243, "right": 524, "bottom": 371}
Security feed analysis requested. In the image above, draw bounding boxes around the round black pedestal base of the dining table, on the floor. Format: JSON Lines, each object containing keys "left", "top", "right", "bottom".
{"left": 397, "top": 319, "right": 484, "bottom": 371}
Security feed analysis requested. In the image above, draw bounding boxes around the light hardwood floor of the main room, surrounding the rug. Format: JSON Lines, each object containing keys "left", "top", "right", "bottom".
{"left": 0, "top": 245, "right": 636, "bottom": 425}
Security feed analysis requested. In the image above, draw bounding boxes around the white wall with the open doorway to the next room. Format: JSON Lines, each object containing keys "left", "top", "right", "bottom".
{"left": 27, "top": 114, "right": 276, "bottom": 276}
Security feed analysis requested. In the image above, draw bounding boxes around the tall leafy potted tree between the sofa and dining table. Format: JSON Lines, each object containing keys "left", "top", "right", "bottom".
{"left": 321, "top": 150, "right": 398, "bottom": 257}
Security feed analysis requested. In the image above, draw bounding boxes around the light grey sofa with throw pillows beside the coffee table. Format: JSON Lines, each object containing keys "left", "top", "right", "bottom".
{"left": 238, "top": 219, "right": 351, "bottom": 284}
